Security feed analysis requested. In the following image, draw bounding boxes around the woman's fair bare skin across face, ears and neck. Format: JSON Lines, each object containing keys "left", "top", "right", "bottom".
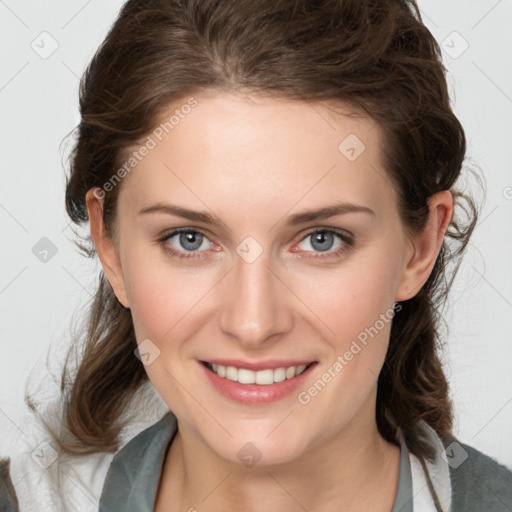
{"left": 87, "top": 91, "right": 453, "bottom": 512}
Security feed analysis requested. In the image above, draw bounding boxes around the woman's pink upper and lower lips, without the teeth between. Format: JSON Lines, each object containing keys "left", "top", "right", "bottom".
{"left": 197, "top": 359, "right": 317, "bottom": 405}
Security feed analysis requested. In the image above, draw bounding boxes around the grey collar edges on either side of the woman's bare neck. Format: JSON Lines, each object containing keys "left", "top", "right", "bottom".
{"left": 99, "top": 412, "right": 413, "bottom": 512}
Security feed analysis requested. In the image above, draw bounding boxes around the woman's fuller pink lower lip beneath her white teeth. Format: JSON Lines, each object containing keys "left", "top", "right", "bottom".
{"left": 198, "top": 361, "right": 316, "bottom": 404}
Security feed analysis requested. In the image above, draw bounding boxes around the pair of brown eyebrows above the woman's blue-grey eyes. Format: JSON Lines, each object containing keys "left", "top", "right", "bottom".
{"left": 139, "top": 202, "right": 375, "bottom": 226}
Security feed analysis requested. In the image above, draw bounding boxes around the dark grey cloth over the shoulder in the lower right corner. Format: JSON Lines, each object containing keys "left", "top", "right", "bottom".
{"left": 443, "top": 436, "right": 512, "bottom": 512}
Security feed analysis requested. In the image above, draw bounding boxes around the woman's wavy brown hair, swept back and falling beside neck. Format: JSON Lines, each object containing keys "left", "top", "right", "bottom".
{"left": 27, "top": 0, "right": 478, "bottom": 472}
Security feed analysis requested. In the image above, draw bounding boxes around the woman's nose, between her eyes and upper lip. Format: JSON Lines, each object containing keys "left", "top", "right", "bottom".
{"left": 220, "top": 253, "right": 293, "bottom": 350}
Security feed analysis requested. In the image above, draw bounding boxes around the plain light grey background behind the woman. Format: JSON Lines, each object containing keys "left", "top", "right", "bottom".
{"left": 0, "top": 0, "right": 512, "bottom": 467}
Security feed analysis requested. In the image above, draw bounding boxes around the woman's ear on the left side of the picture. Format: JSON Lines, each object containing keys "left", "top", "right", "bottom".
{"left": 85, "top": 187, "right": 130, "bottom": 308}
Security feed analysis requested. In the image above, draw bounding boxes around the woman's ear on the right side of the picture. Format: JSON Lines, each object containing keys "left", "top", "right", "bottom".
{"left": 395, "top": 190, "right": 453, "bottom": 301}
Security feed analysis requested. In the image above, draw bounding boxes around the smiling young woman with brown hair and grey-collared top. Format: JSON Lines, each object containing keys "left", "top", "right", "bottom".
{"left": 4, "top": 0, "right": 512, "bottom": 512}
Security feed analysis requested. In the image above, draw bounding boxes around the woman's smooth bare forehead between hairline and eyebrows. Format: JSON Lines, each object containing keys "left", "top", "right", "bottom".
{"left": 115, "top": 91, "right": 394, "bottom": 224}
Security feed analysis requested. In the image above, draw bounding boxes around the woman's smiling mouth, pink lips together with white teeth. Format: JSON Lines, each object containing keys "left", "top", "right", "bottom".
{"left": 198, "top": 360, "right": 318, "bottom": 405}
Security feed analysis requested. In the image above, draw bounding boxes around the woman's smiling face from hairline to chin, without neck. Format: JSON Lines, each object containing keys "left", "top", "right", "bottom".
{"left": 86, "top": 91, "right": 446, "bottom": 464}
